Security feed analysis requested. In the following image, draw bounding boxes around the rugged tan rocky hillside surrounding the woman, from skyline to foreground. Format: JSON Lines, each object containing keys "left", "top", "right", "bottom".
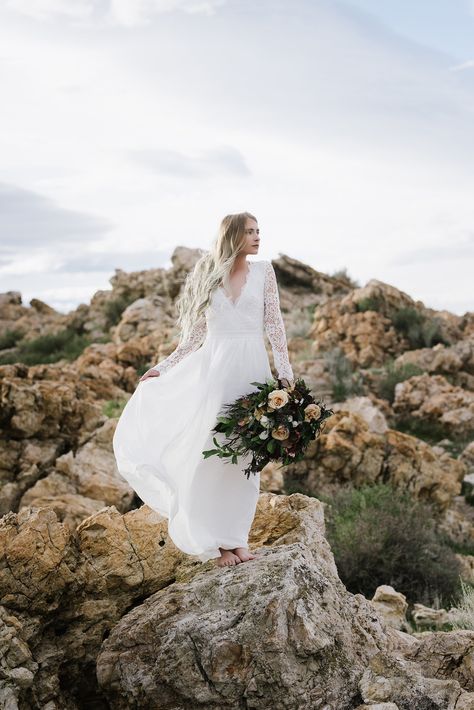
{"left": 0, "top": 247, "right": 474, "bottom": 710}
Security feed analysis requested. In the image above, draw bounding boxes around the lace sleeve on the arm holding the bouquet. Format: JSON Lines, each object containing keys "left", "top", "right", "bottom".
{"left": 263, "top": 261, "right": 293, "bottom": 380}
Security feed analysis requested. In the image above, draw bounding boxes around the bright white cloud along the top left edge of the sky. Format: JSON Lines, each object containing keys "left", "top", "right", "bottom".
{"left": 5, "top": 0, "right": 227, "bottom": 27}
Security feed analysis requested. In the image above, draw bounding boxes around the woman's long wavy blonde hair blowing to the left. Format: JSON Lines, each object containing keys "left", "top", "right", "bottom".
{"left": 175, "top": 212, "right": 257, "bottom": 345}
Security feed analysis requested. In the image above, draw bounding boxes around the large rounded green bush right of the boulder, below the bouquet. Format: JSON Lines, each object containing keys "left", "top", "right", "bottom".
{"left": 326, "top": 483, "right": 461, "bottom": 606}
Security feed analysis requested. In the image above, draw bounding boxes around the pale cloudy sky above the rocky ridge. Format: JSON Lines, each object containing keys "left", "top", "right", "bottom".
{"left": 0, "top": 0, "right": 474, "bottom": 315}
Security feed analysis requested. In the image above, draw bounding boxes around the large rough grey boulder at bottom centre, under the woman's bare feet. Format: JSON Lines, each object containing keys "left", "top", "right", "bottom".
{"left": 97, "top": 542, "right": 384, "bottom": 710}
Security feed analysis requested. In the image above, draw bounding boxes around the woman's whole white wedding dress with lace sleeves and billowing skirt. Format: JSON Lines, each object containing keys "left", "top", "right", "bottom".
{"left": 113, "top": 260, "right": 293, "bottom": 562}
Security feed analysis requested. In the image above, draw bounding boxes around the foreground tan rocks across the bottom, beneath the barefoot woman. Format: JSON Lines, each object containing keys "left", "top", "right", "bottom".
{"left": 0, "top": 493, "right": 474, "bottom": 710}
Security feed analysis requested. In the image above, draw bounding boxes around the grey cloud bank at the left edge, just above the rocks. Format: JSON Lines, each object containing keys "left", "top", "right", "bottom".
{"left": 0, "top": 183, "right": 114, "bottom": 258}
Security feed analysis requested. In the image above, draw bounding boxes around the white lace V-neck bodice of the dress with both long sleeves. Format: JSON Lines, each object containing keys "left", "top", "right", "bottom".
{"left": 153, "top": 260, "right": 294, "bottom": 380}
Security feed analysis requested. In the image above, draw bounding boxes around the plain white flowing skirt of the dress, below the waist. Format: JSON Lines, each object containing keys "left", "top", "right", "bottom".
{"left": 113, "top": 333, "right": 272, "bottom": 562}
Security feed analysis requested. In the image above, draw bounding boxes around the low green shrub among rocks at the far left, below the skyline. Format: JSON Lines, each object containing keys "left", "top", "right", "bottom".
{"left": 0, "top": 328, "right": 91, "bottom": 365}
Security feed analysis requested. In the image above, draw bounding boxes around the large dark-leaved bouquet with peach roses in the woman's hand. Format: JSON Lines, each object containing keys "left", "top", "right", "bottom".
{"left": 202, "top": 378, "right": 334, "bottom": 478}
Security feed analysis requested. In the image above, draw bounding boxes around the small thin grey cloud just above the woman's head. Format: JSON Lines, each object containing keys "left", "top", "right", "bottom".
{"left": 129, "top": 146, "right": 251, "bottom": 179}
